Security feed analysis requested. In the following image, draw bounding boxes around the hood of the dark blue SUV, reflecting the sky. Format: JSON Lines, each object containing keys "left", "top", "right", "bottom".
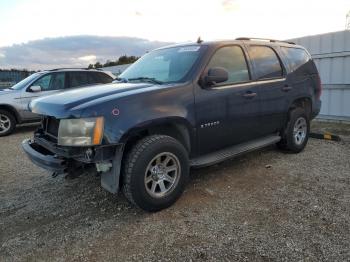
{"left": 29, "top": 83, "right": 160, "bottom": 118}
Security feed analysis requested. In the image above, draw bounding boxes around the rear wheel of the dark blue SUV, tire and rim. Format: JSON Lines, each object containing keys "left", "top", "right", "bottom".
{"left": 277, "top": 107, "right": 310, "bottom": 153}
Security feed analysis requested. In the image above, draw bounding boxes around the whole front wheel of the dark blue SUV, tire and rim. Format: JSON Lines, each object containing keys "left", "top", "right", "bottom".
{"left": 123, "top": 135, "right": 189, "bottom": 212}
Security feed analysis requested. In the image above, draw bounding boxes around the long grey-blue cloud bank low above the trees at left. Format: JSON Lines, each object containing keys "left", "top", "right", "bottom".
{"left": 0, "top": 35, "right": 169, "bottom": 70}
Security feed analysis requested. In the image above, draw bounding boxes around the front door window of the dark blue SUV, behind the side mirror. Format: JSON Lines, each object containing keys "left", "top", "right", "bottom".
{"left": 207, "top": 46, "right": 250, "bottom": 85}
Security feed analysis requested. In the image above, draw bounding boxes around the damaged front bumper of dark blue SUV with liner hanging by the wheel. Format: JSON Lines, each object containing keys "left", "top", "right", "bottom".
{"left": 22, "top": 134, "right": 124, "bottom": 193}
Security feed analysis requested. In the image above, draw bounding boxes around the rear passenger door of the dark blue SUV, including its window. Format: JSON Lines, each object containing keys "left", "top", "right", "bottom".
{"left": 247, "top": 44, "right": 292, "bottom": 136}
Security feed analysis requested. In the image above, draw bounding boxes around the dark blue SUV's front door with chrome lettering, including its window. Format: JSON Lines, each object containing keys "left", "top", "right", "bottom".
{"left": 195, "top": 45, "right": 260, "bottom": 154}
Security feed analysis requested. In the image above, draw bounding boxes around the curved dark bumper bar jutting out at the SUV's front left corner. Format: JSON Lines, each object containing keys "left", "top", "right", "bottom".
{"left": 22, "top": 139, "right": 67, "bottom": 173}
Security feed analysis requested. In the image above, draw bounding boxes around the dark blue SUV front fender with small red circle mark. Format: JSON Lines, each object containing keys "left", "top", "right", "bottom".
{"left": 83, "top": 84, "right": 195, "bottom": 144}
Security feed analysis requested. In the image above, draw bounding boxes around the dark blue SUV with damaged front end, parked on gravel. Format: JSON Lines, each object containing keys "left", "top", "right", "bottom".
{"left": 22, "top": 38, "right": 322, "bottom": 211}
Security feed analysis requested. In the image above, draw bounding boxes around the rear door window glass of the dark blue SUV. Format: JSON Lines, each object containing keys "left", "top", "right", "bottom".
{"left": 249, "top": 46, "right": 283, "bottom": 79}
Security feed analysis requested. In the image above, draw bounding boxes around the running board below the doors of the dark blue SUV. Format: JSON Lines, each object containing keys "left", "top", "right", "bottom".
{"left": 190, "top": 135, "right": 281, "bottom": 167}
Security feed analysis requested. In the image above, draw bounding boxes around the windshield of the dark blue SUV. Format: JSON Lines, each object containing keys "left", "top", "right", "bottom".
{"left": 119, "top": 45, "right": 201, "bottom": 84}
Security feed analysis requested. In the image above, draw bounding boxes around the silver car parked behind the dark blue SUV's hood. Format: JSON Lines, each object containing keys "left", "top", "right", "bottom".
{"left": 0, "top": 69, "right": 115, "bottom": 136}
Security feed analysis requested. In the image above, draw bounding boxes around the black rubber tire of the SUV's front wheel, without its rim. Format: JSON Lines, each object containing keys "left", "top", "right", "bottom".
{"left": 123, "top": 135, "right": 189, "bottom": 212}
